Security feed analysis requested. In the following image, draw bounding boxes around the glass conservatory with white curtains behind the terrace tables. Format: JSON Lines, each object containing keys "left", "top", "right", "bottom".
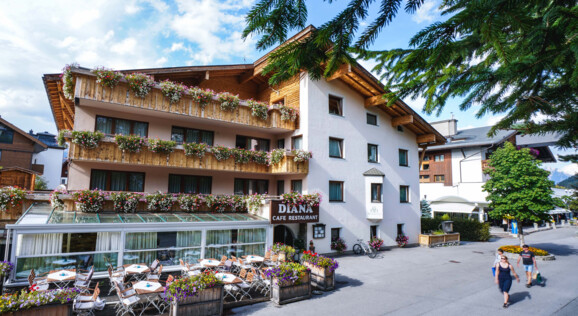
{"left": 6, "top": 204, "right": 272, "bottom": 282}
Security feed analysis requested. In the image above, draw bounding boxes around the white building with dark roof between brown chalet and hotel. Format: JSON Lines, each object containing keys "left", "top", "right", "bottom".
{"left": 29, "top": 130, "right": 66, "bottom": 190}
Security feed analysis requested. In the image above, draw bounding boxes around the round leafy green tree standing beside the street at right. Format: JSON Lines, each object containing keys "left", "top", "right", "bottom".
{"left": 483, "top": 142, "right": 556, "bottom": 245}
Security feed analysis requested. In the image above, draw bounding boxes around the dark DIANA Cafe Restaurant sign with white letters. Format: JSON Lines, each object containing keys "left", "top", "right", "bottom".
{"left": 270, "top": 201, "right": 319, "bottom": 224}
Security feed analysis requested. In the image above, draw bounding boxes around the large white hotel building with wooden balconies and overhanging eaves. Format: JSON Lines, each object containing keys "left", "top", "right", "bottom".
{"left": 3, "top": 27, "right": 445, "bottom": 282}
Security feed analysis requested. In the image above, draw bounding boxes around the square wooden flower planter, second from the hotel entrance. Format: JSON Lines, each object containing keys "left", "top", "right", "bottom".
{"left": 265, "top": 262, "right": 311, "bottom": 305}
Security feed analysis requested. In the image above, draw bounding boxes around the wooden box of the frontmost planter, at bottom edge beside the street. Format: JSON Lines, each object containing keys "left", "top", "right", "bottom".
{"left": 169, "top": 285, "right": 223, "bottom": 316}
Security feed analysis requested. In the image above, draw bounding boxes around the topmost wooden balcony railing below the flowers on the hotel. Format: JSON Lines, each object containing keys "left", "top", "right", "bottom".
{"left": 75, "top": 75, "right": 298, "bottom": 131}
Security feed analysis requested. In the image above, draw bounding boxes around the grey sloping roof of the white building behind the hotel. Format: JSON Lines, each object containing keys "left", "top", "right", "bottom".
{"left": 427, "top": 126, "right": 517, "bottom": 150}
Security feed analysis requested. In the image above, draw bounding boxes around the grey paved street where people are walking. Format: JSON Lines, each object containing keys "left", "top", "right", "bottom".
{"left": 226, "top": 227, "right": 578, "bottom": 316}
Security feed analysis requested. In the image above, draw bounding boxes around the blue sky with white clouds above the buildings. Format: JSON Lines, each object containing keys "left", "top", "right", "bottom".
{"left": 0, "top": 0, "right": 578, "bottom": 175}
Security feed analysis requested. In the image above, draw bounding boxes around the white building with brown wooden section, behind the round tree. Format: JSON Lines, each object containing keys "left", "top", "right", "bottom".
{"left": 419, "top": 119, "right": 556, "bottom": 221}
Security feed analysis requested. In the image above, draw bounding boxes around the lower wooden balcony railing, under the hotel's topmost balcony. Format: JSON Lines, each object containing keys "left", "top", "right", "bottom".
{"left": 69, "top": 141, "right": 309, "bottom": 175}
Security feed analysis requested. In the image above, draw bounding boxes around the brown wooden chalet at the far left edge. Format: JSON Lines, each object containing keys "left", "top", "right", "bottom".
{"left": 0, "top": 117, "right": 48, "bottom": 190}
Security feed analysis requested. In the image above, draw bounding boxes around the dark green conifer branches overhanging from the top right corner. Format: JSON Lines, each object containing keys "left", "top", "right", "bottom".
{"left": 243, "top": 0, "right": 578, "bottom": 153}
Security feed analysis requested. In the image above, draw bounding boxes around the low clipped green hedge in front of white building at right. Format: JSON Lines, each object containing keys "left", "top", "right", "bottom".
{"left": 421, "top": 218, "right": 490, "bottom": 241}
